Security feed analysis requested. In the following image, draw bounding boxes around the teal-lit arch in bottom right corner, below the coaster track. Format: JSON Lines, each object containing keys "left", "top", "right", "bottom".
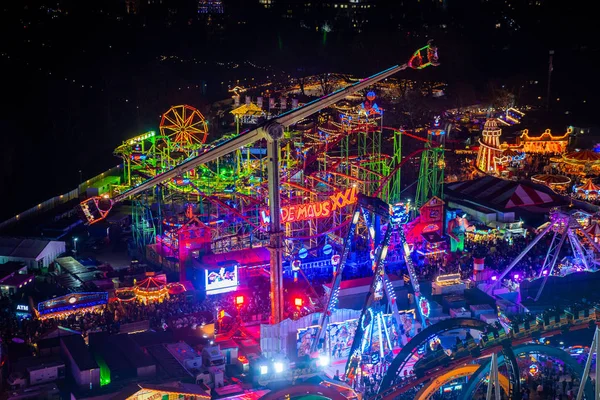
{"left": 462, "top": 344, "right": 594, "bottom": 400}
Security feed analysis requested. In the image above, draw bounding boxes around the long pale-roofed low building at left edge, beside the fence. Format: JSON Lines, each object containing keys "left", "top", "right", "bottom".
{"left": 0, "top": 237, "right": 66, "bottom": 269}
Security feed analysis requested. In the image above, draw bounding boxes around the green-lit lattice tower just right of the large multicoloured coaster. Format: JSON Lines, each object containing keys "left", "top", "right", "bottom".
{"left": 415, "top": 117, "right": 446, "bottom": 210}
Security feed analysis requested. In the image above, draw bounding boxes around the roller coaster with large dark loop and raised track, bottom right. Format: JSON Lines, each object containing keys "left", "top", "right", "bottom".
{"left": 374, "top": 304, "right": 600, "bottom": 400}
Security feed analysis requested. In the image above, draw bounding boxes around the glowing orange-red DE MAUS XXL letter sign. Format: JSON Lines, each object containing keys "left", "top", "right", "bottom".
{"left": 280, "top": 188, "right": 358, "bottom": 223}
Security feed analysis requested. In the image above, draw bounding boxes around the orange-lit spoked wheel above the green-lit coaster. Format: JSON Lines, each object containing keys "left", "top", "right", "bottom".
{"left": 160, "top": 105, "right": 208, "bottom": 155}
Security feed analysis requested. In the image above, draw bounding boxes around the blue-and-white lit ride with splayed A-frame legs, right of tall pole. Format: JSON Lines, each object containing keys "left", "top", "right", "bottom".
{"left": 304, "top": 195, "right": 428, "bottom": 380}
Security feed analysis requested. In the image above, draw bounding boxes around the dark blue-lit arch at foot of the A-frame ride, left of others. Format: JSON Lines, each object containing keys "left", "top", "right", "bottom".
{"left": 379, "top": 318, "right": 496, "bottom": 394}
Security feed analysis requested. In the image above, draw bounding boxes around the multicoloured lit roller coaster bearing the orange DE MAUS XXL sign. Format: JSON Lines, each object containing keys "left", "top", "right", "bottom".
{"left": 109, "top": 92, "right": 437, "bottom": 258}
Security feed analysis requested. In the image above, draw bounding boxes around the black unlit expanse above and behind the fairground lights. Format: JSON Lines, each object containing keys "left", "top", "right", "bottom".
{"left": 0, "top": 0, "right": 600, "bottom": 220}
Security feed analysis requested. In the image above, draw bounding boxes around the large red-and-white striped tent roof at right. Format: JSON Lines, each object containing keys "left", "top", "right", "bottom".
{"left": 447, "top": 175, "right": 563, "bottom": 209}
